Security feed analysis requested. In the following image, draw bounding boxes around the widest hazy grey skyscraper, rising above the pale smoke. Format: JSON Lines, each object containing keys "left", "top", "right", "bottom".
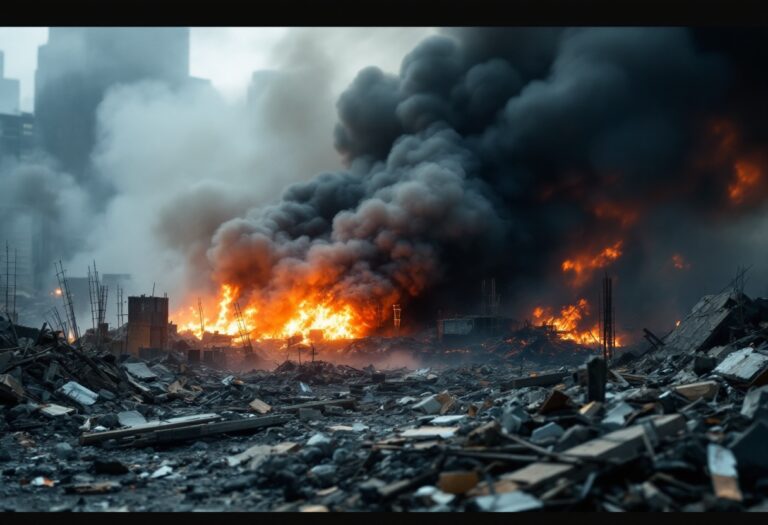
{"left": 35, "top": 27, "right": 190, "bottom": 180}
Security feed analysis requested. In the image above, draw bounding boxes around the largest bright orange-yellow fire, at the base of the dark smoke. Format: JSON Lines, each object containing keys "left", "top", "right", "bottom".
{"left": 176, "top": 284, "right": 367, "bottom": 342}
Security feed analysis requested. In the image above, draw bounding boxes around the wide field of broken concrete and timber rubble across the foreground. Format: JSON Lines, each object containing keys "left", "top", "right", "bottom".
{"left": 0, "top": 293, "right": 768, "bottom": 512}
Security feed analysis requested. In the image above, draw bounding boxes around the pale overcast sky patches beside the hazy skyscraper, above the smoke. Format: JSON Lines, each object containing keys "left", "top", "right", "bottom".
{"left": 0, "top": 27, "right": 434, "bottom": 111}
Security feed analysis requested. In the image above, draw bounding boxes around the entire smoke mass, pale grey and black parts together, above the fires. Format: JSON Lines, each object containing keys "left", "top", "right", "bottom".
{"left": 8, "top": 28, "right": 768, "bottom": 336}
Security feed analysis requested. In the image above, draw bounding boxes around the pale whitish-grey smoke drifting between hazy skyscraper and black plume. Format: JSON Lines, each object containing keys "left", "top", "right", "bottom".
{"left": 70, "top": 29, "right": 436, "bottom": 306}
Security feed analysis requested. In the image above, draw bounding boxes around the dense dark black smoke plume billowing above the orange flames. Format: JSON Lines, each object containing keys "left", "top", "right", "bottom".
{"left": 184, "top": 28, "right": 765, "bottom": 334}
